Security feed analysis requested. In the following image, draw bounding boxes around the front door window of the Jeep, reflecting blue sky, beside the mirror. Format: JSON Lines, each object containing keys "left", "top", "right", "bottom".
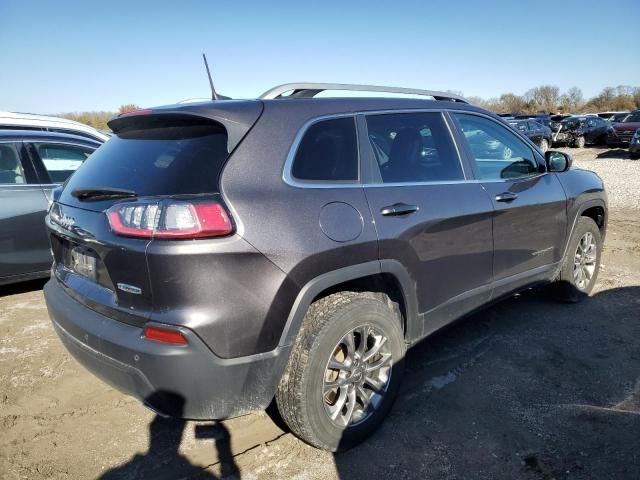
{"left": 454, "top": 113, "right": 538, "bottom": 180}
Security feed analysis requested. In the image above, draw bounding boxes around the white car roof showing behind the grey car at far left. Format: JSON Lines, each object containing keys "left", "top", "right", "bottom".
{"left": 0, "top": 112, "right": 109, "bottom": 143}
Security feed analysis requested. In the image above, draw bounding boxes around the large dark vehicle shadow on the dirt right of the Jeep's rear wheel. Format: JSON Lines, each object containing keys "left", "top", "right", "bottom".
{"left": 334, "top": 286, "right": 640, "bottom": 480}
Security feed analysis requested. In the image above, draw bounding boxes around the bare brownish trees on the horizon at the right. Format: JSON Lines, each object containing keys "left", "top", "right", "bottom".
{"left": 468, "top": 85, "right": 640, "bottom": 113}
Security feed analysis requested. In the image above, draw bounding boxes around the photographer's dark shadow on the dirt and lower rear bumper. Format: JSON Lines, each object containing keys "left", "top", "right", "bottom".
{"left": 99, "top": 391, "right": 240, "bottom": 480}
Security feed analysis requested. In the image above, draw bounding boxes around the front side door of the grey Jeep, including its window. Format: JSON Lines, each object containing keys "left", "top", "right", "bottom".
{"left": 453, "top": 112, "right": 567, "bottom": 296}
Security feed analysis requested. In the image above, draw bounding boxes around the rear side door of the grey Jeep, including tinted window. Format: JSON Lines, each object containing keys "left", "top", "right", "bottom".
{"left": 360, "top": 111, "right": 493, "bottom": 339}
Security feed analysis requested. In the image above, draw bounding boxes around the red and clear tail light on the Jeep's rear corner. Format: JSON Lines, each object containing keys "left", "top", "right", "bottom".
{"left": 107, "top": 201, "right": 233, "bottom": 239}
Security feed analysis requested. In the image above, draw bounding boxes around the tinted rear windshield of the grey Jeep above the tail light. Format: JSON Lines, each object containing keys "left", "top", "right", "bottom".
{"left": 67, "top": 125, "right": 228, "bottom": 196}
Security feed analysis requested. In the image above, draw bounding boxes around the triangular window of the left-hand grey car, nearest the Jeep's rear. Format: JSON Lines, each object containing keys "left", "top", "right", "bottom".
{"left": 28, "top": 141, "right": 96, "bottom": 201}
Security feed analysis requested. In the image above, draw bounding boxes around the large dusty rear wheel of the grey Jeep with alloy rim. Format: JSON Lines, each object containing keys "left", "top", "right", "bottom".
{"left": 276, "top": 292, "right": 406, "bottom": 452}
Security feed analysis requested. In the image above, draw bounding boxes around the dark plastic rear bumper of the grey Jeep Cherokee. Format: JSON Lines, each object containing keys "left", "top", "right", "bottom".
{"left": 44, "top": 278, "right": 290, "bottom": 419}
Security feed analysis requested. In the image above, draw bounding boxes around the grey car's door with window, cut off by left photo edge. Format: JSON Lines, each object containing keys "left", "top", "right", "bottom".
{"left": 0, "top": 141, "right": 51, "bottom": 283}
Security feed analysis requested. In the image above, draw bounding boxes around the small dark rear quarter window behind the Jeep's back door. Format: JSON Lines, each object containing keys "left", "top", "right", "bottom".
{"left": 291, "top": 117, "right": 358, "bottom": 182}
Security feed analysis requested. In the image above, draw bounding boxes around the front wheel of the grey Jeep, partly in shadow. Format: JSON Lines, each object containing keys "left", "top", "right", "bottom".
{"left": 552, "top": 217, "right": 602, "bottom": 303}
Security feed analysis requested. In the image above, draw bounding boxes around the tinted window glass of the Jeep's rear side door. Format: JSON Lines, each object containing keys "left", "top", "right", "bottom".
{"left": 367, "top": 112, "right": 464, "bottom": 183}
